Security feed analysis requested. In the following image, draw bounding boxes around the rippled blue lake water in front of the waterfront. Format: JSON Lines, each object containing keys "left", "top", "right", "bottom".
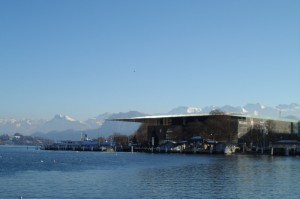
{"left": 0, "top": 146, "right": 300, "bottom": 199}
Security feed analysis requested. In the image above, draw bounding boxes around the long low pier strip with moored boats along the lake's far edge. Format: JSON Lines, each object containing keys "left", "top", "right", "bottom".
{"left": 41, "top": 140, "right": 300, "bottom": 156}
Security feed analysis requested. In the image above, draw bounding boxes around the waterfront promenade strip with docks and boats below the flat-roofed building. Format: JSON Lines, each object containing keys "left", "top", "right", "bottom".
{"left": 41, "top": 142, "right": 300, "bottom": 156}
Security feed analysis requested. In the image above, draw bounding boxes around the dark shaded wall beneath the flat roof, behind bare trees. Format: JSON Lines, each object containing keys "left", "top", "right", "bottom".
{"left": 148, "top": 116, "right": 238, "bottom": 145}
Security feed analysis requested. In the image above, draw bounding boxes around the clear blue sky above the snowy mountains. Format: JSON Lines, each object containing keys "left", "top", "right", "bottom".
{"left": 0, "top": 0, "right": 300, "bottom": 119}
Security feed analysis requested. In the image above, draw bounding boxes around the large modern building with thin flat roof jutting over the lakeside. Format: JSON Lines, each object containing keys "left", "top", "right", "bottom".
{"left": 115, "top": 114, "right": 300, "bottom": 145}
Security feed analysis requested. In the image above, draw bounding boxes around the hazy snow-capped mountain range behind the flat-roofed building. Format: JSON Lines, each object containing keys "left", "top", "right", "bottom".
{"left": 0, "top": 103, "right": 300, "bottom": 140}
